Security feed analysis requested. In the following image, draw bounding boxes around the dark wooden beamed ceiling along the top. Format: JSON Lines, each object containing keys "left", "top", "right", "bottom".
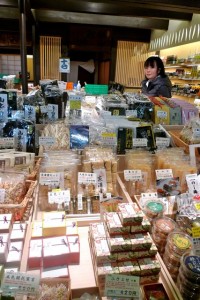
{"left": 0, "top": 0, "right": 200, "bottom": 30}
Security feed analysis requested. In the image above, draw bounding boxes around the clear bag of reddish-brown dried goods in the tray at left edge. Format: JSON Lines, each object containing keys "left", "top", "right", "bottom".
{"left": 0, "top": 172, "right": 27, "bottom": 204}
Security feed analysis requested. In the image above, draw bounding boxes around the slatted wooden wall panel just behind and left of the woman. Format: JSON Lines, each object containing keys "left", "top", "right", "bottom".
{"left": 115, "top": 41, "right": 154, "bottom": 87}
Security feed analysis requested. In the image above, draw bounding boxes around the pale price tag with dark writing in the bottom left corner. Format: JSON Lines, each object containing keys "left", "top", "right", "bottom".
{"left": 1, "top": 272, "right": 40, "bottom": 295}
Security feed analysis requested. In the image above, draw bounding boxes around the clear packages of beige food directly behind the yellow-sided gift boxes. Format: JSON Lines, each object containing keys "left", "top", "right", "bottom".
{"left": 39, "top": 151, "right": 80, "bottom": 213}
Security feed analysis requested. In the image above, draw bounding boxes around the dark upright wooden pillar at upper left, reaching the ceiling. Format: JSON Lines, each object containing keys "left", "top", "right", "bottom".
{"left": 18, "top": 0, "right": 28, "bottom": 94}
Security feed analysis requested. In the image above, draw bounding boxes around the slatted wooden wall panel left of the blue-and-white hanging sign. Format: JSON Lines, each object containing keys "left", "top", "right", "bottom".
{"left": 40, "top": 36, "right": 61, "bottom": 80}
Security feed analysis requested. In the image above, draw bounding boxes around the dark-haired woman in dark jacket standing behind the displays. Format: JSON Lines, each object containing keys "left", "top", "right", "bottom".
{"left": 141, "top": 56, "right": 172, "bottom": 98}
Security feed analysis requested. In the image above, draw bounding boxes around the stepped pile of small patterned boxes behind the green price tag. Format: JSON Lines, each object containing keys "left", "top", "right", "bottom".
{"left": 89, "top": 203, "right": 161, "bottom": 296}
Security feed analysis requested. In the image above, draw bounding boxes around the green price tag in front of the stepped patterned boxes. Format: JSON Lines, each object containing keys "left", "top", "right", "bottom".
{"left": 105, "top": 274, "right": 140, "bottom": 300}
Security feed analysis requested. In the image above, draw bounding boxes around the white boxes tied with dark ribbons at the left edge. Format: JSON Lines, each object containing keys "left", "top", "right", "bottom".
{"left": 0, "top": 214, "right": 27, "bottom": 280}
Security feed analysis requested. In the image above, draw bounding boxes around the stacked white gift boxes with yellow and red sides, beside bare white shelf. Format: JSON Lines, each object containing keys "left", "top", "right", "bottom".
{"left": 28, "top": 211, "right": 80, "bottom": 278}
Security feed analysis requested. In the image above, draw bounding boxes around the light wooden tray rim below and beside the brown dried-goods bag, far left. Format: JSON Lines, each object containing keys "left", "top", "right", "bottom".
{"left": 0, "top": 181, "right": 37, "bottom": 221}
